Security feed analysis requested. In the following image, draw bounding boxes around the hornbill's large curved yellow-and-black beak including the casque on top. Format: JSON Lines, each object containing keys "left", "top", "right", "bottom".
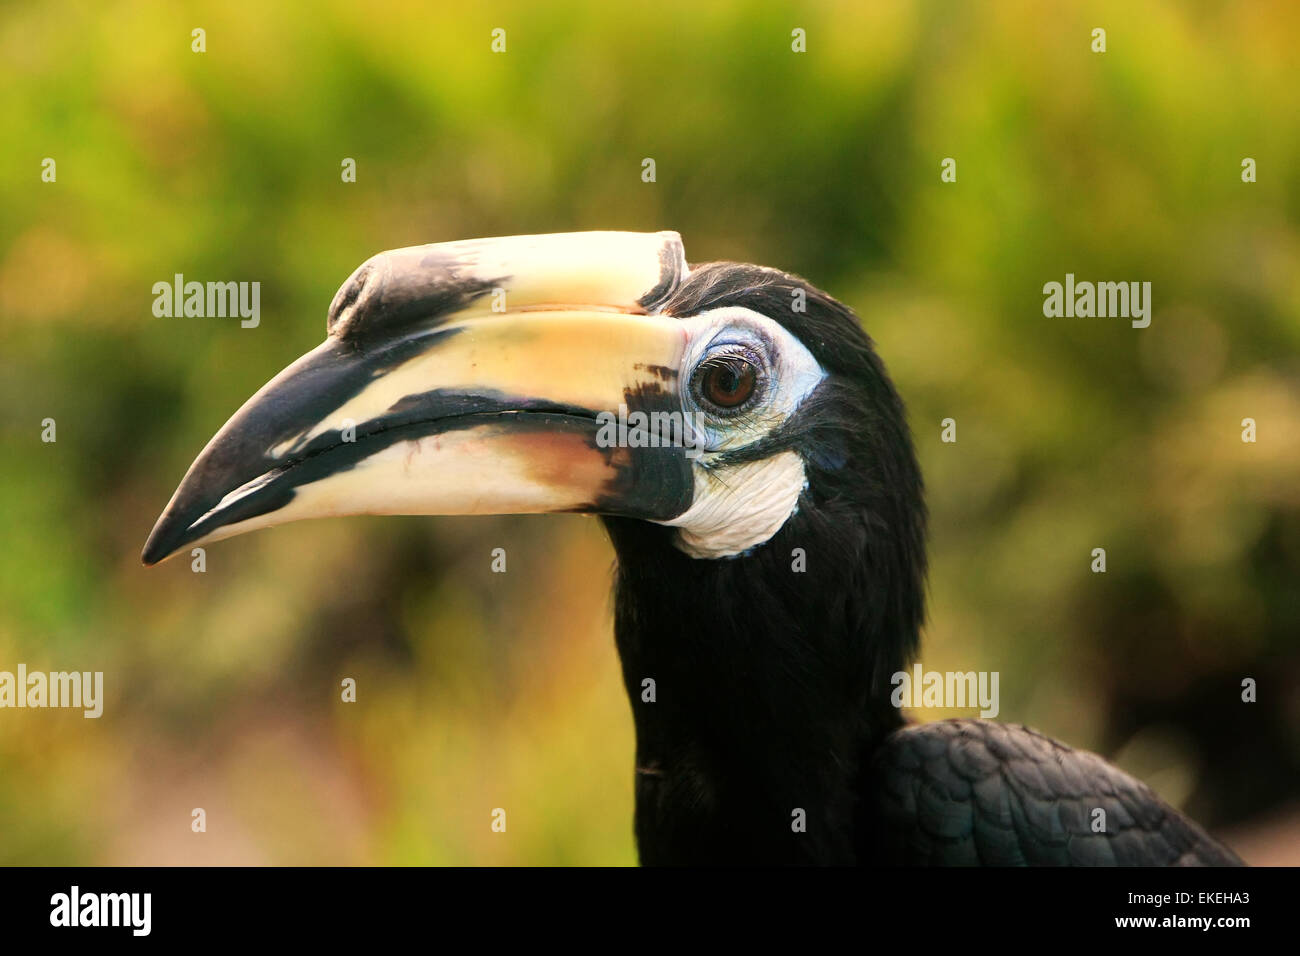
{"left": 142, "top": 233, "right": 692, "bottom": 564}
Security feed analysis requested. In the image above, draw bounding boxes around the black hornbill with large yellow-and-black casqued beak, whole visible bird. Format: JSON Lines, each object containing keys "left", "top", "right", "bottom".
{"left": 143, "top": 232, "right": 1240, "bottom": 865}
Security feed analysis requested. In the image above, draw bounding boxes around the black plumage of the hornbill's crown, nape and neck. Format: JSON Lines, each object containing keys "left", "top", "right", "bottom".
{"left": 606, "top": 264, "right": 926, "bottom": 864}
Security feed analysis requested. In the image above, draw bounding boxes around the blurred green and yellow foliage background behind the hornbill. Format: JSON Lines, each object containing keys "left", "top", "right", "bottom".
{"left": 0, "top": 0, "right": 1300, "bottom": 864}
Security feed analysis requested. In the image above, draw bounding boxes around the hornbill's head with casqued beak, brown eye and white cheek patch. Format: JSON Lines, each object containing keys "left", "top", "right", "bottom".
{"left": 143, "top": 232, "right": 924, "bottom": 691}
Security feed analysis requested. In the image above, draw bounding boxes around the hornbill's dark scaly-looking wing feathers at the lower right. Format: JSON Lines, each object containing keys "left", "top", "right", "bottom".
{"left": 862, "top": 721, "right": 1242, "bottom": 866}
